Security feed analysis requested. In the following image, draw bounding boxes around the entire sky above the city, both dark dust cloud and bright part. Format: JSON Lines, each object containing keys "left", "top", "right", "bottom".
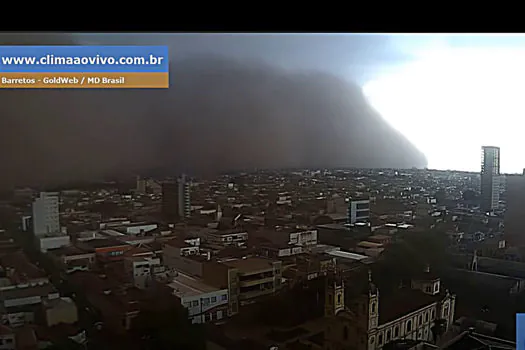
{"left": 0, "top": 33, "right": 525, "bottom": 184}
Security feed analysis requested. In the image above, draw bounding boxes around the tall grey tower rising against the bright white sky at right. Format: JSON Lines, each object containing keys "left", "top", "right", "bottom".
{"left": 481, "top": 146, "right": 501, "bottom": 211}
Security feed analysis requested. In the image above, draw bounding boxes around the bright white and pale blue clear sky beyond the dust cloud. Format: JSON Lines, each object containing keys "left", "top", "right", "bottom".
{"left": 74, "top": 34, "right": 525, "bottom": 172}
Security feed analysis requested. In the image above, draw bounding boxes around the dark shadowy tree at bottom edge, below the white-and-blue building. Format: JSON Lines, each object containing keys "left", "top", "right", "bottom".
{"left": 132, "top": 305, "right": 206, "bottom": 350}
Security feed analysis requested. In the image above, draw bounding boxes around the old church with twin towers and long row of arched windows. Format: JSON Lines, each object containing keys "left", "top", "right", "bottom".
{"left": 324, "top": 267, "right": 456, "bottom": 350}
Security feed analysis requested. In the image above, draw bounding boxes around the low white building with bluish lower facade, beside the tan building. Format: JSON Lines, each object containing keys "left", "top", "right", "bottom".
{"left": 168, "top": 273, "right": 228, "bottom": 323}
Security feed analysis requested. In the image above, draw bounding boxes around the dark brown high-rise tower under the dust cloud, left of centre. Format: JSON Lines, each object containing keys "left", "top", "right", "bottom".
{"left": 162, "top": 175, "right": 191, "bottom": 220}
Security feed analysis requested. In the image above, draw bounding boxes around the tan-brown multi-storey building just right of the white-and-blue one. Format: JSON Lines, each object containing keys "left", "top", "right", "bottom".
{"left": 202, "top": 257, "right": 282, "bottom": 314}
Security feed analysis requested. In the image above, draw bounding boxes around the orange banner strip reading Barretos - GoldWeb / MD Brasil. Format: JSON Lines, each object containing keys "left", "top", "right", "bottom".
{"left": 0, "top": 72, "right": 170, "bottom": 89}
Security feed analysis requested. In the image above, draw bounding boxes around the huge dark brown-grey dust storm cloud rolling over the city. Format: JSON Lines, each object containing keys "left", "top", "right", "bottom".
{"left": 0, "top": 32, "right": 426, "bottom": 189}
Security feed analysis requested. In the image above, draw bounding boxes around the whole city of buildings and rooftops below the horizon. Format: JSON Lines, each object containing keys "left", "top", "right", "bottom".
{"left": 0, "top": 146, "right": 525, "bottom": 349}
